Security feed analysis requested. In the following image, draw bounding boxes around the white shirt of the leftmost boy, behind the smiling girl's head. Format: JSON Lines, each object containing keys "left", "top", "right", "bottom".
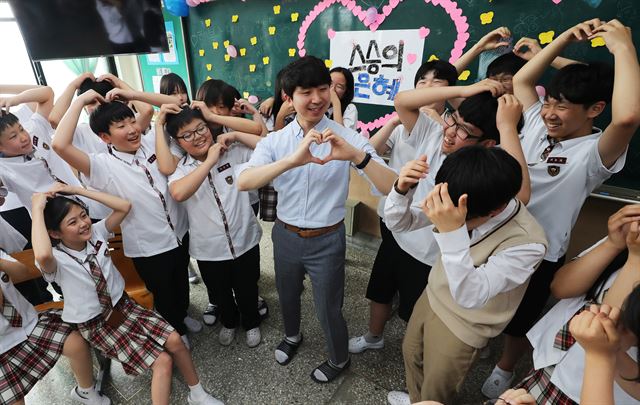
{"left": 0, "top": 113, "right": 110, "bottom": 218}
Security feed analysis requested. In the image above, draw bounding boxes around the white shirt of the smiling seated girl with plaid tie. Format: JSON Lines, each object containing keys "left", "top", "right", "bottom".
{"left": 36, "top": 219, "right": 124, "bottom": 323}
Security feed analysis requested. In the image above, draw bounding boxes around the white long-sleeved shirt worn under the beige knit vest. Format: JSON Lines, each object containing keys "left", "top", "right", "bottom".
{"left": 434, "top": 199, "right": 545, "bottom": 308}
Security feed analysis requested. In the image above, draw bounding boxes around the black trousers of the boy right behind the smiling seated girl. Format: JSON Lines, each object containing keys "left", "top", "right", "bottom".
{"left": 133, "top": 233, "right": 189, "bottom": 335}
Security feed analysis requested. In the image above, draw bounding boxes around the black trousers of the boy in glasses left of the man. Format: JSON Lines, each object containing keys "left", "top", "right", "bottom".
{"left": 198, "top": 245, "right": 260, "bottom": 330}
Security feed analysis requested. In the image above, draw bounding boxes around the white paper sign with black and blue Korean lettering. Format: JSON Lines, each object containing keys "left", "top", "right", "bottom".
{"left": 330, "top": 30, "right": 424, "bottom": 106}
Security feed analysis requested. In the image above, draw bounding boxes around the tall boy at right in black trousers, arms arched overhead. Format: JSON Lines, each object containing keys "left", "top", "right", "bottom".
{"left": 482, "top": 19, "right": 640, "bottom": 396}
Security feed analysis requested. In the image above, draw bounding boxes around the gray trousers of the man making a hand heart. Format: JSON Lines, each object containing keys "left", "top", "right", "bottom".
{"left": 271, "top": 221, "right": 349, "bottom": 364}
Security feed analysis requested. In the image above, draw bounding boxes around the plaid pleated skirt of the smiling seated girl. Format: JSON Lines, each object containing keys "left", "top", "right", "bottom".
{"left": 78, "top": 295, "right": 174, "bottom": 375}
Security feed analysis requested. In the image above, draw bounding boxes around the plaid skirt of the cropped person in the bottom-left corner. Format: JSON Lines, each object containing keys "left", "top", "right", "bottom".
{"left": 0, "top": 310, "right": 73, "bottom": 404}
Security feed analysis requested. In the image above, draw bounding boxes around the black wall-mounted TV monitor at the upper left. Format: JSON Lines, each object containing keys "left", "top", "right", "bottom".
{"left": 5, "top": 0, "right": 168, "bottom": 60}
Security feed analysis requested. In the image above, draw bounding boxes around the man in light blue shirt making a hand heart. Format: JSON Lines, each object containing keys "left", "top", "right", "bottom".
{"left": 238, "top": 56, "right": 395, "bottom": 382}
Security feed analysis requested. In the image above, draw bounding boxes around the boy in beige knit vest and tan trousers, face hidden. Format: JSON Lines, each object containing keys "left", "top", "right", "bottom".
{"left": 388, "top": 145, "right": 547, "bottom": 404}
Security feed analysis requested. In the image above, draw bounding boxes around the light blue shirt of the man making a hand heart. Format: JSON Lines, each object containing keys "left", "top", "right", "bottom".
{"left": 239, "top": 117, "right": 386, "bottom": 228}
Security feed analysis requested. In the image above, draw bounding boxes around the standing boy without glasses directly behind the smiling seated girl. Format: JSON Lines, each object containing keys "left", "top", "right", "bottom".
{"left": 53, "top": 90, "right": 202, "bottom": 342}
